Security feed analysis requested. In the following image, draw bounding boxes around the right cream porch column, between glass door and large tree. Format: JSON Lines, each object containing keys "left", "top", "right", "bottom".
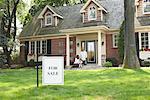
{"left": 98, "top": 31, "right": 102, "bottom": 66}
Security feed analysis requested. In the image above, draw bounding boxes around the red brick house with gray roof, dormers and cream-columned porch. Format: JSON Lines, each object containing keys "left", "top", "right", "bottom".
{"left": 19, "top": 0, "right": 150, "bottom": 66}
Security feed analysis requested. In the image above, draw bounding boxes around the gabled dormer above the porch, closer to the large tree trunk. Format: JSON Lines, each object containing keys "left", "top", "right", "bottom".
{"left": 80, "top": 0, "right": 107, "bottom": 23}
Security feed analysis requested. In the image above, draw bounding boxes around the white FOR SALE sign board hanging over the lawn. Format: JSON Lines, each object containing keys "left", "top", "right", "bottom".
{"left": 42, "top": 56, "right": 64, "bottom": 85}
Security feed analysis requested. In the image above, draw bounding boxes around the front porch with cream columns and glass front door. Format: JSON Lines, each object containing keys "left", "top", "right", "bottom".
{"left": 66, "top": 30, "right": 106, "bottom": 66}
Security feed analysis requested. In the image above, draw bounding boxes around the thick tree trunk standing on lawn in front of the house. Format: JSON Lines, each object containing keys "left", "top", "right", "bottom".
{"left": 123, "top": 0, "right": 140, "bottom": 68}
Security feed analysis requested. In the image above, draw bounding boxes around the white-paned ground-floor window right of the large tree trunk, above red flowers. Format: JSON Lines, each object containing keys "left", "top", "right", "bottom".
{"left": 141, "top": 33, "right": 149, "bottom": 49}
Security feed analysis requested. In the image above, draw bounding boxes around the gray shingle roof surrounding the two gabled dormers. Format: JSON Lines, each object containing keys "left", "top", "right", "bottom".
{"left": 21, "top": 0, "right": 150, "bottom": 37}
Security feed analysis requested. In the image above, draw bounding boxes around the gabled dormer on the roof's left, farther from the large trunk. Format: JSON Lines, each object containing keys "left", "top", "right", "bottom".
{"left": 38, "top": 5, "right": 63, "bottom": 28}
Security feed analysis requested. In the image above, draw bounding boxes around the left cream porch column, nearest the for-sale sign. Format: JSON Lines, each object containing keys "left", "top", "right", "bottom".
{"left": 66, "top": 34, "right": 70, "bottom": 66}
